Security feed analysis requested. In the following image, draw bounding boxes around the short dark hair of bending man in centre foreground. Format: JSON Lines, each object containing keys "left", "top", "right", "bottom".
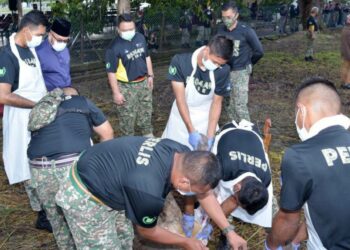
{"left": 181, "top": 151, "right": 221, "bottom": 188}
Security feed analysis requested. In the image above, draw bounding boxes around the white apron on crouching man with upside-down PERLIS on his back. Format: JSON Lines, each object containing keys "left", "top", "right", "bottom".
{"left": 212, "top": 120, "right": 273, "bottom": 227}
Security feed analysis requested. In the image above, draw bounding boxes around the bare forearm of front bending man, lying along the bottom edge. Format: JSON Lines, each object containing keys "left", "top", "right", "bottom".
{"left": 136, "top": 225, "right": 208, "bottom": 250}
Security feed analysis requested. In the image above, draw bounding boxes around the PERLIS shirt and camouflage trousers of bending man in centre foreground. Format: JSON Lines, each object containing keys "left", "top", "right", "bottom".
{"left": 56, "top": 137, "right": 190, "bottom": 249}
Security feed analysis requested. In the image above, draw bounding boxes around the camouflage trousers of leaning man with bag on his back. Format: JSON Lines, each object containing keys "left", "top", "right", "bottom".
{"left": 30, "top": 157, "right": 77, "bottom": 249}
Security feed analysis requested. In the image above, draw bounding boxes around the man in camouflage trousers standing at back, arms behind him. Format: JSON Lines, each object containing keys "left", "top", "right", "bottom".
{"left": 218, "top": 2, "right": 264, "bottom": 121}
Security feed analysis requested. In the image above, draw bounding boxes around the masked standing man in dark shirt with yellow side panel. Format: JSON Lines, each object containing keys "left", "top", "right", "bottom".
{"left": 106, "top": 14, "right": 153, "bottom": 136}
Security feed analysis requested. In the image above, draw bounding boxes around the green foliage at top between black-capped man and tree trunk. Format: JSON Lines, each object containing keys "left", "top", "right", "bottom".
{"left": 51, "top": 0, "right": 110, "bottom": 33}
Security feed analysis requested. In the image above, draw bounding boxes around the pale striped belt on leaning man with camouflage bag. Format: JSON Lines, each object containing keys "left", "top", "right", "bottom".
{"left": 29, "top": 153, "right": 79, "bottom": 168}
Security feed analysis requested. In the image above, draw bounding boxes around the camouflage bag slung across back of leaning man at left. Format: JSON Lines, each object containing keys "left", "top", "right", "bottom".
{"left": 28, "top": 88, "right": 64, "bottom": 131}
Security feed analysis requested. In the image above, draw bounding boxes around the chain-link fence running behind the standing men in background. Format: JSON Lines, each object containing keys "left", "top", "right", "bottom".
{"left": 0, "top": 6, "right": 300, "bottom": 64}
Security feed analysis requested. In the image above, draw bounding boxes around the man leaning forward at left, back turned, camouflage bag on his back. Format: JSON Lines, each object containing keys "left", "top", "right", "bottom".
{"left": 28, "top": 88, "right": 113, "bottom": 249}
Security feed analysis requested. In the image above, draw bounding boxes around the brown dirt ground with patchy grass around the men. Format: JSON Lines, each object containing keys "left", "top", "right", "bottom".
{"left": 0, "top": 30, "right": 350, "bottom": 249}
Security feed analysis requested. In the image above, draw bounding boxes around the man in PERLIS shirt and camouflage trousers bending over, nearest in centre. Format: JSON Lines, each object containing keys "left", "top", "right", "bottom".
{"left": 56, "top": 136, "right": 247, "bottom": 250}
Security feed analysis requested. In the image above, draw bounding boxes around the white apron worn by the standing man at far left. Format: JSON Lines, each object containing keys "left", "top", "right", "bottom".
{"left": 3, "top": 34, "right": 46, "bottom": 184}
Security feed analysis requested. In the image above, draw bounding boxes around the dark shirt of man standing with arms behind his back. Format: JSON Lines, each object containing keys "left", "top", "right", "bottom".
{"left": 218, "top": 22, "right": 264, "bottom": 70}
